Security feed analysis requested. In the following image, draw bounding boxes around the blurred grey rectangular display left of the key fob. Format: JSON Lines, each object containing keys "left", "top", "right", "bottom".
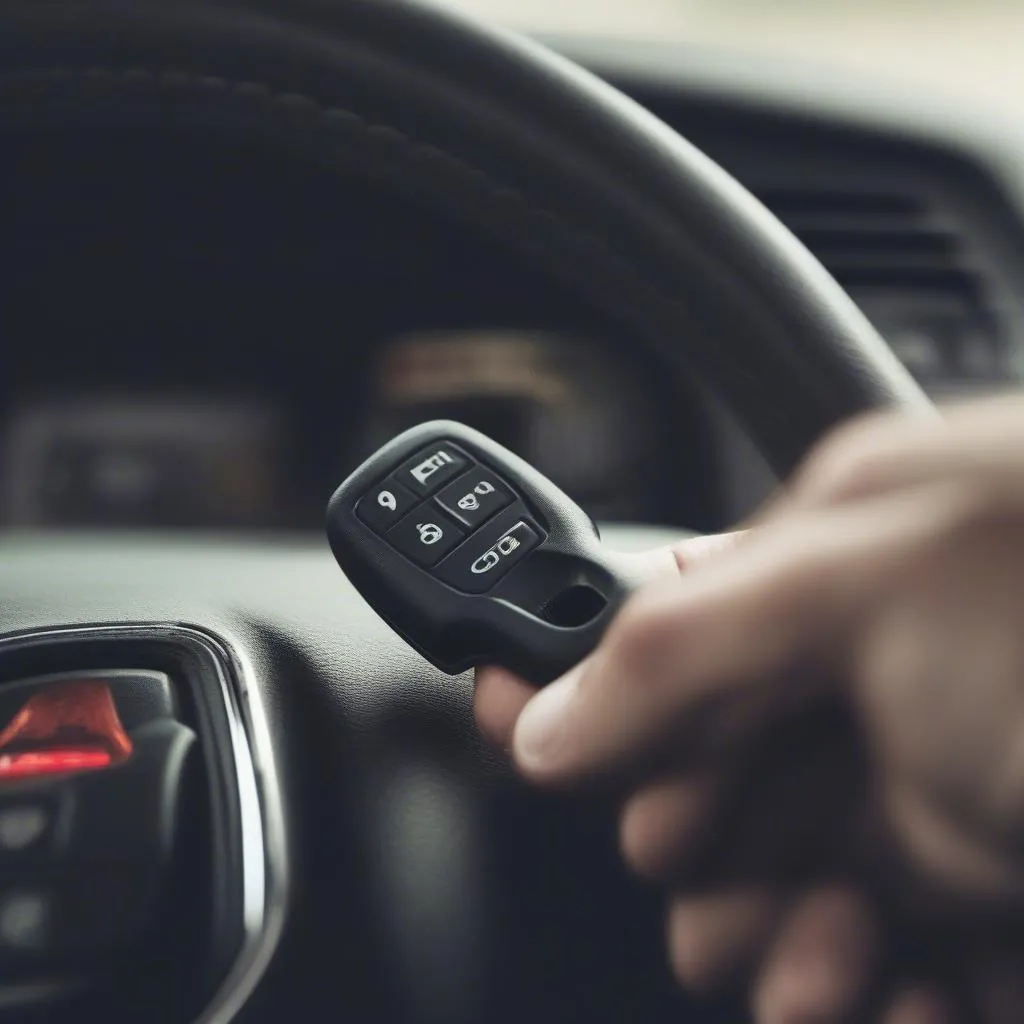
{"left": 0, "top": 398, "right": 285, "bottom": 527}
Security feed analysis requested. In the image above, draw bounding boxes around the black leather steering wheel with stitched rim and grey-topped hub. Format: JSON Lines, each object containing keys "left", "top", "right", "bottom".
{"left": 0, "top": 0, "right": 929, "bottom": 1022}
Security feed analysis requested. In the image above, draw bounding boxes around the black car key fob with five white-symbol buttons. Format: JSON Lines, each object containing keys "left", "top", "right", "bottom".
{"left": 327, "top": 420, "right": 639, "bottom": 684}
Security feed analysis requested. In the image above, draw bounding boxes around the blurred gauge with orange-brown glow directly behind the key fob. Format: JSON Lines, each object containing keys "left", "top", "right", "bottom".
{"left": 367, "top": 331, "right": 651, "bottom": 518}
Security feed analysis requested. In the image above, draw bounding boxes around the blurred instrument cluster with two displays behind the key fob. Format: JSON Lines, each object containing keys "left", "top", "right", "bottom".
{"left": 2, "top": 328, "right": 696, "bottom": 528}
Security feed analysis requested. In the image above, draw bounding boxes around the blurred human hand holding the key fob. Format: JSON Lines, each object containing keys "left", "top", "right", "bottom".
{"left": 476, "top": 399, "right": 1024, "bottom": 1024}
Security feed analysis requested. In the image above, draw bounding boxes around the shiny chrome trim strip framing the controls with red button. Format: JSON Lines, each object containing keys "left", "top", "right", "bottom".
{"left": 0, "top": 622, "right": 288, "bottom": 1024}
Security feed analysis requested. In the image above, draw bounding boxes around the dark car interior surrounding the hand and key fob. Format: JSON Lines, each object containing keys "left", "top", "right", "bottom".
{"left": 0, "top": 0, "right": 1011, "bottom": 1024}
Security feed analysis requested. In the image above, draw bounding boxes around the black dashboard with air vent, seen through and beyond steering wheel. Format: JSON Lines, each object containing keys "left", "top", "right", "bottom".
{"left": 0, "top": 39, "right": 1024, "bottom": 529}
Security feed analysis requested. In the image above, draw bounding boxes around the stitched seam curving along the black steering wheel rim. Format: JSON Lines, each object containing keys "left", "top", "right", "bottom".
{"left": 0, "top": 67, "right": 797, "bottom": 437}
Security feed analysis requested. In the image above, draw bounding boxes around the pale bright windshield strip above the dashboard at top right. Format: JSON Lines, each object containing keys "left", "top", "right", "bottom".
{"left": 455, "top": 0, "right": 1024, "bottom": 116}
